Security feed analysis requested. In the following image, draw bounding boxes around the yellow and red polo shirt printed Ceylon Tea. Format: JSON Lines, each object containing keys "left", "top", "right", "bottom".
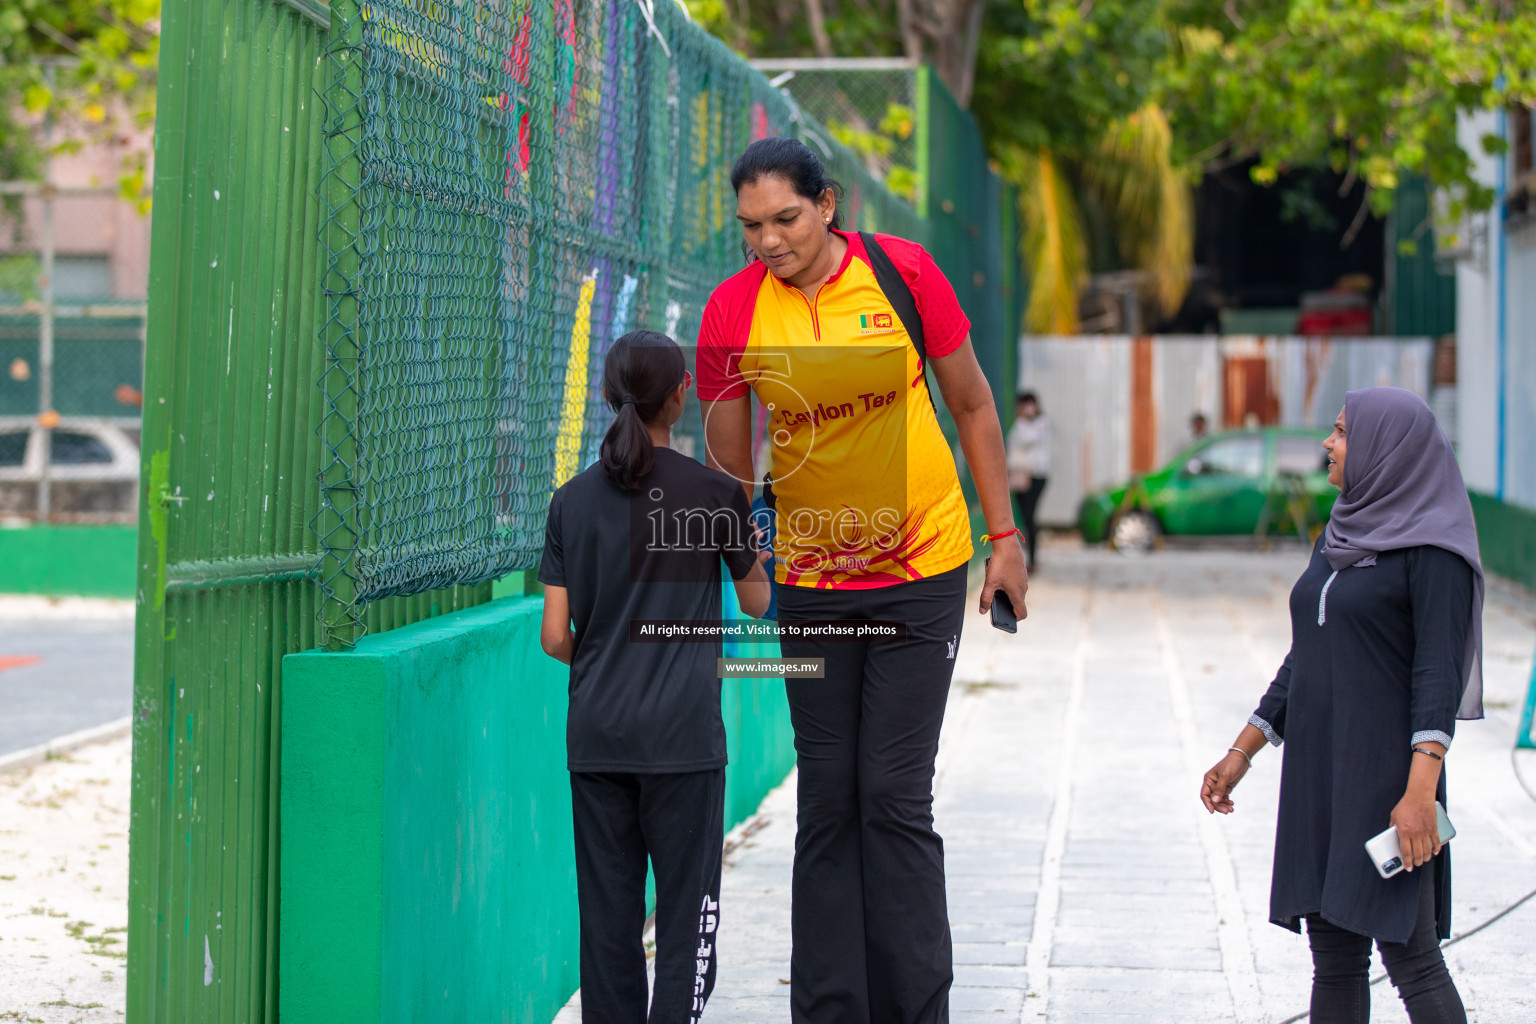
{"left": 696, "top": 232, "right": 972, "bottom": 590}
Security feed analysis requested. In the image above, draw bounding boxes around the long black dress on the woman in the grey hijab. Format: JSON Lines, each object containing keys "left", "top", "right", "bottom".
{"left": 1250, "top": 542, "right": 1473, "bottom": 943}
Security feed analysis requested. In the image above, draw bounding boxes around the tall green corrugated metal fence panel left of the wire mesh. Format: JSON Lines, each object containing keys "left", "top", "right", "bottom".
{"left": 127, "top": 0, "right": 490, "bottom": 1024}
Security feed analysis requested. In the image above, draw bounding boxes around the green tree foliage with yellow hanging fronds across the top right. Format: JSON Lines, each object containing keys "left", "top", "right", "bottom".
{"left": 703, "top": 0, "right": 1536, "bottom": 332}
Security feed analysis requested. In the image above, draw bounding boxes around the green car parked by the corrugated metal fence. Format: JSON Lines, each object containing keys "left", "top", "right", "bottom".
{"left": 1077, "top": 427, "right": 1338, "bottom": 554}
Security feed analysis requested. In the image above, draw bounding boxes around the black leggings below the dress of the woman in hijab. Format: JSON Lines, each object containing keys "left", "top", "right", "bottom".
{"left": 1307, "top": 864, "right": 1467, "bottom": 1024}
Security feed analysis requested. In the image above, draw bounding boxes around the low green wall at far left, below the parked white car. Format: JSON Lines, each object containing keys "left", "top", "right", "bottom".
{"left": 0, "top": 525, "right": 138, "bottom": 597}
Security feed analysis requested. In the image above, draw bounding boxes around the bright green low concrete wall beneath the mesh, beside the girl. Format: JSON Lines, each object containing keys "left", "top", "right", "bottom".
{"left": 280, "top": 580, "right": 794, "bottom": 1024}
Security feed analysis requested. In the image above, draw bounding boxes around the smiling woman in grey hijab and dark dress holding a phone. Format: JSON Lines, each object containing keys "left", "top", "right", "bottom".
{"left": 1201, "top": 387, "right": 1482, "bottom": 1024}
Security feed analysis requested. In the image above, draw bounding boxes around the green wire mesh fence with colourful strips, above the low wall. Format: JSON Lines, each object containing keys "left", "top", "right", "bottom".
{"left": 313, "top": 0, "right": 923, "bottom": 645}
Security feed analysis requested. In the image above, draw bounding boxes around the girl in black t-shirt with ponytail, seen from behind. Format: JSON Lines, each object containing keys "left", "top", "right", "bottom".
{"left": 539, "top": 330, "right": 770, "bottom": 1024}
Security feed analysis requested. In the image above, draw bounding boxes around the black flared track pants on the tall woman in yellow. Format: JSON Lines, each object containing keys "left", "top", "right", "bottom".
{"left": 779, "top": 565, "right": 966, "bottom": 1024}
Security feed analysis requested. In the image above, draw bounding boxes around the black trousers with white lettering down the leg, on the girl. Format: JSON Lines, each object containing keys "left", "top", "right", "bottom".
{"left": 571, "top": 768, "right": 725, "bottom": 1024}
